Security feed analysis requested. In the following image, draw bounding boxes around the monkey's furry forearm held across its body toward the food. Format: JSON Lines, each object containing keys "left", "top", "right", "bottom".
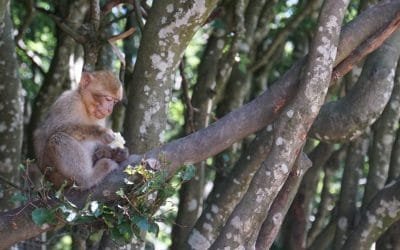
{"left": 57, "top": 124, "right": 114, "bottom": 144}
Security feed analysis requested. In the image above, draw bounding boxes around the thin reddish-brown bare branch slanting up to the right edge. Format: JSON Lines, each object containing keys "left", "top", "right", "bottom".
{"left": 332, "top": 11, "right": 400, "bottom": 80}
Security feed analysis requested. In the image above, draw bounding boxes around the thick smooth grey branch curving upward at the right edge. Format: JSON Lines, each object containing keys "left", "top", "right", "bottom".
{"left": 310, "top": 32, "right": 400, "bottom": 141}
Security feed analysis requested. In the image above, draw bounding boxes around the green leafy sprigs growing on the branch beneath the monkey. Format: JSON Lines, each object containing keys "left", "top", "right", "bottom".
{"left": 24, "top": 164, "right": 195, "bottom": 244}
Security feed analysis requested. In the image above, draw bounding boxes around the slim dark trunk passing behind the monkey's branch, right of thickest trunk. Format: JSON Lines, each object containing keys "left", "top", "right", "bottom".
{"left": 171, "top": 28, "right": 222, "bottom": 249}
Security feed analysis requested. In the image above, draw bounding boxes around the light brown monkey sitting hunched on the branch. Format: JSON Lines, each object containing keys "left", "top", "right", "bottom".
{"left": 34, "top": 71, "right": 128, "bottom": 190}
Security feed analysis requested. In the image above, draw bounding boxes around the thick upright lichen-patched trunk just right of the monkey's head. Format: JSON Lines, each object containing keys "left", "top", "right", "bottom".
{"left": 124, "top": 0, "right": 217, "bottom": 153}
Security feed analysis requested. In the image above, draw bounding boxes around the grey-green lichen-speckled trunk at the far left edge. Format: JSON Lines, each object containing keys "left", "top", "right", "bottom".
{"left": 0, "top": 2, "right": 24, "bottom": 210}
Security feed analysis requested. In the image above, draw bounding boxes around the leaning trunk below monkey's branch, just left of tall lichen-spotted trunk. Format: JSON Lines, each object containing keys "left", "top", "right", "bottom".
{"left": 188, "top": 126, "right": 272, "bottom": 250}
